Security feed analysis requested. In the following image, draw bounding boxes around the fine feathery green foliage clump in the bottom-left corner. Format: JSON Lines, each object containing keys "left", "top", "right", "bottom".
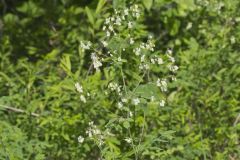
{"left": 0, "top": 122, "right": 46, "bottom": 160}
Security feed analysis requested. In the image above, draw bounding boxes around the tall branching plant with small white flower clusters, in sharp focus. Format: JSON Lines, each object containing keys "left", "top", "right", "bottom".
{"left": 75, "top": 5, "right": 178, "bottom": 159}
